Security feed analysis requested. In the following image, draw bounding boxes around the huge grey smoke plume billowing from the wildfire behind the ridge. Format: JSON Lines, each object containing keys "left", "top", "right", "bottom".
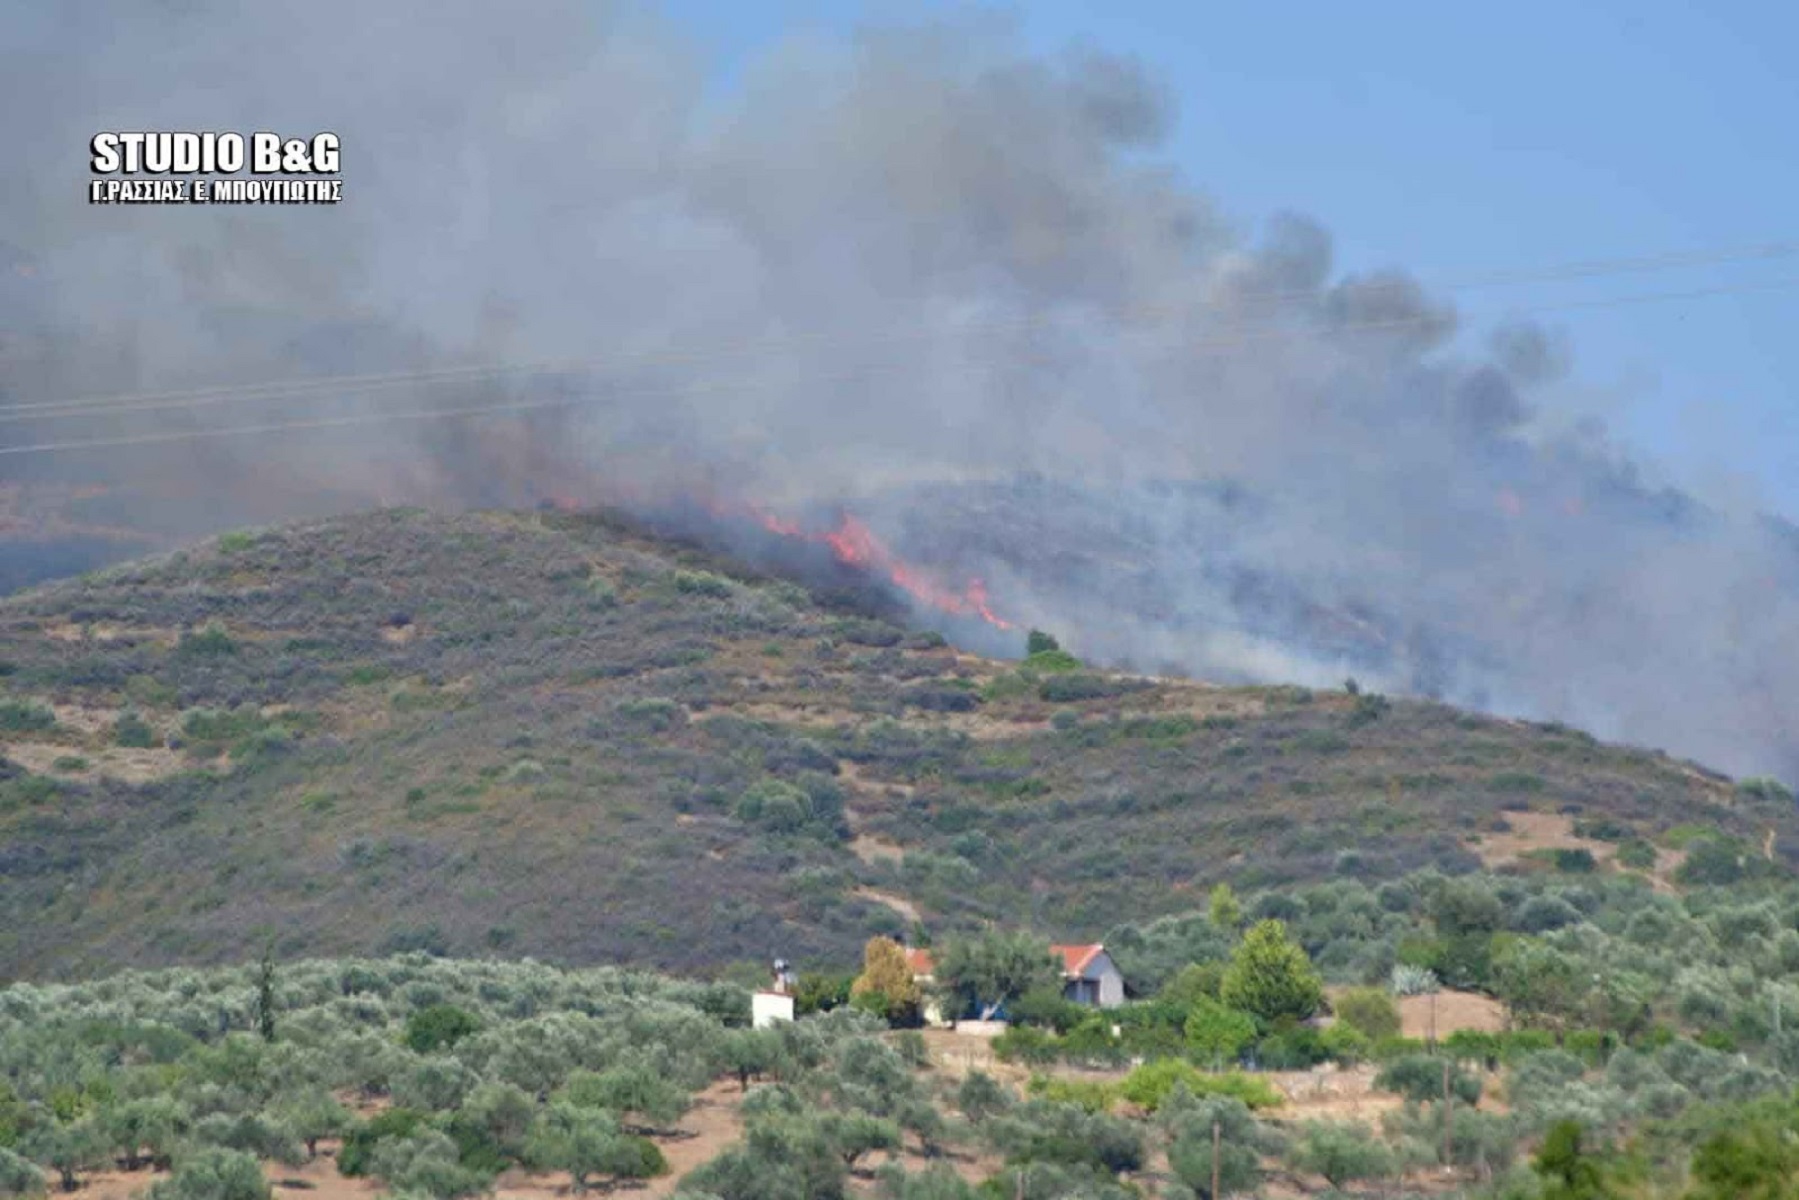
{"left": 0, "top": 0, "right": 1799, "bottom": 777}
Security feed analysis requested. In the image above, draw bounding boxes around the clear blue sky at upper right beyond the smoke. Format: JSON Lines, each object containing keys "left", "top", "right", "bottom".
{"left": 664, "top": 0, "right": 1799, "bottom": 516}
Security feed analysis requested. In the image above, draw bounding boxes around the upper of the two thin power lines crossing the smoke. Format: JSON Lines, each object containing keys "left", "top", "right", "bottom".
{"left": 0, "top": 241, "right": 1799, "bottom": 425}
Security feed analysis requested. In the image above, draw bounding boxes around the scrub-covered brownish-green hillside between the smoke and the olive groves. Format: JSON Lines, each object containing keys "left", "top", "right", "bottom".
{"left": 0, "top": 509, "right": 1795, "bottom": 979}
